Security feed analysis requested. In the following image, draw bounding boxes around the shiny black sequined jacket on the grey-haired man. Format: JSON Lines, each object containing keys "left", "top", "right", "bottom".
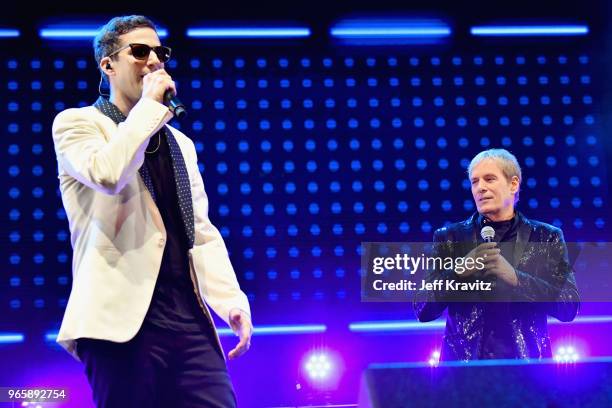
{"left": 414, "top": 212, "right": 579, "bottom": 361}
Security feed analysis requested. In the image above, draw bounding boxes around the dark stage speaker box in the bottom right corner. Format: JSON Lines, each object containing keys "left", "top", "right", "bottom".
{"left": 358, "top": 357, "right": 612, "bottom": 408}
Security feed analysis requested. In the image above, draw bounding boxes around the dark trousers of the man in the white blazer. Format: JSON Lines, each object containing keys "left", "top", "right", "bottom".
{"left": 77, "top": 322, "right": 236, "bottom": 408}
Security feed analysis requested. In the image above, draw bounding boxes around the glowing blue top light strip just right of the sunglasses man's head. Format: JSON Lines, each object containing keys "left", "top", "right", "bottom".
{"left": 187, "top": 27, "right": 310, "bottom": 38}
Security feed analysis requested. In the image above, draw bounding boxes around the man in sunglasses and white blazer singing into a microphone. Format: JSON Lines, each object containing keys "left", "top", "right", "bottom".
{"left": 53, "top": 16, "right": 252, "bottom": 407}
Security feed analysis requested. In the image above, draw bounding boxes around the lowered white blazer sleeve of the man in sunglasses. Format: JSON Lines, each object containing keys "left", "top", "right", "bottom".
{"left": 182, "top": 141, "right": 251, "bottom": 323}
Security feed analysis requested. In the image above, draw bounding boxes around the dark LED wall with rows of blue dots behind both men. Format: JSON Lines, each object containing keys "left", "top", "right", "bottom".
{"left": 0, "top": 41, "right": 610, "bottom": 330}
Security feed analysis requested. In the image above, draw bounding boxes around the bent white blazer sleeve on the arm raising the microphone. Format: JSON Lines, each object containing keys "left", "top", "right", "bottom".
{"left": 52, "top": 98, "right": 172, "bottom": 195}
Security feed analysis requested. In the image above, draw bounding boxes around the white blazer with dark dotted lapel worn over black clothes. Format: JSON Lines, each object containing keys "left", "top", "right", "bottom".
{"left": 53, "top": 98, "right": 250, "bottom": 359}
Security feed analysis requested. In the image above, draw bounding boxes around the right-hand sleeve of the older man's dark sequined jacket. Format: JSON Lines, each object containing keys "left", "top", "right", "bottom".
{"left": 514, "top": 229, "right": 580, "bottom": 322}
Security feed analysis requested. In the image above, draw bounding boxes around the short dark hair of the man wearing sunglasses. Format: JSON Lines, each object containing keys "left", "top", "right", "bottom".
{"left": 93, "top": 15, "right": 156, "bottom": 84}
